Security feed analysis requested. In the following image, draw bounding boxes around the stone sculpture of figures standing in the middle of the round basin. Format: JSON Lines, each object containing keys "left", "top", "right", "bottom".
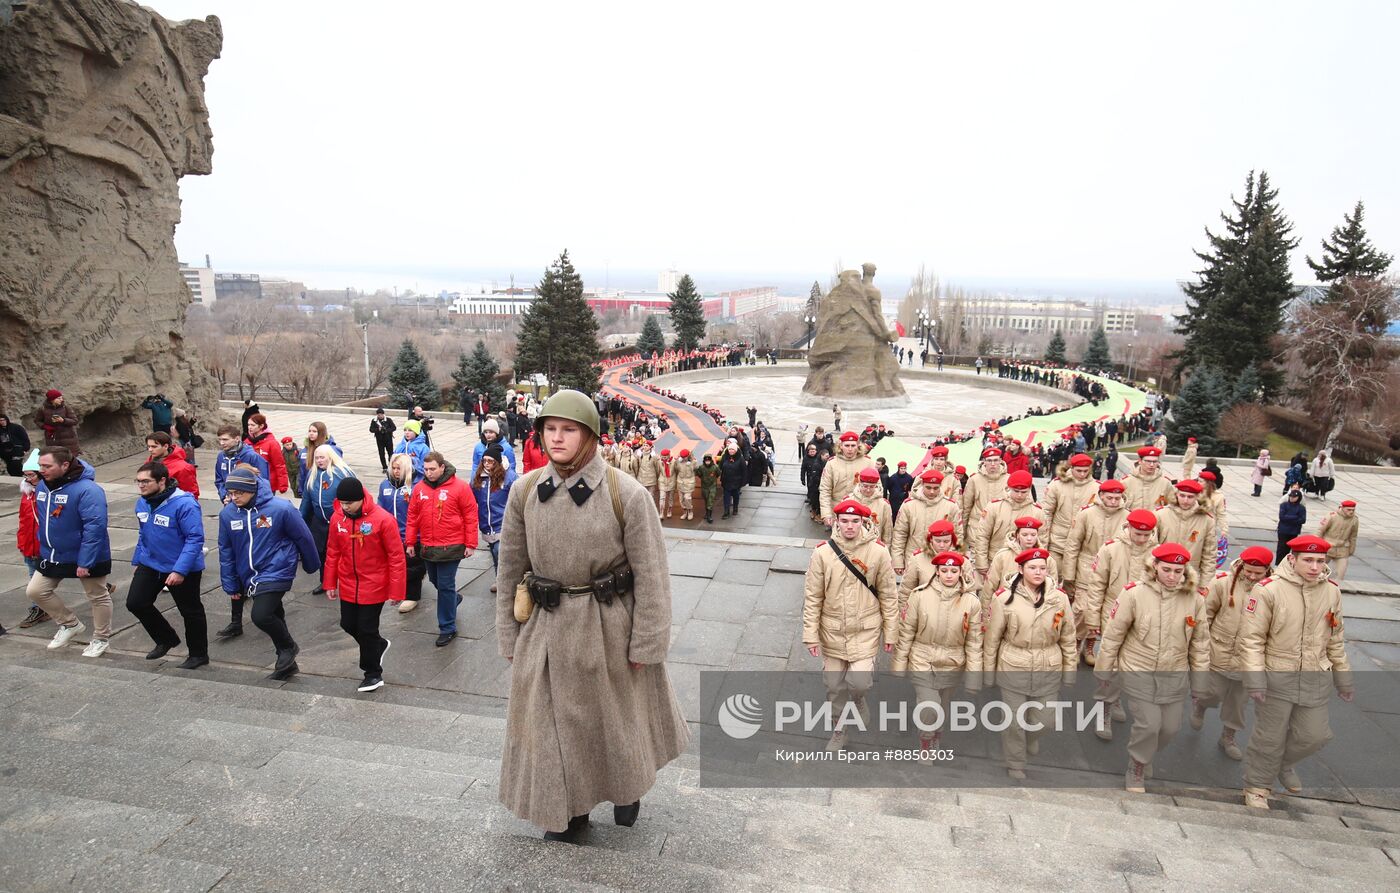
{"left": 799, "top": 263, "right": 909, "bottom": 409}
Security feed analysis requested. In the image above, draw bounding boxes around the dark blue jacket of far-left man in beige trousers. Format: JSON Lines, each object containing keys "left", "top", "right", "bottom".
{"left": 34, "top": 459, "right": 112, "bottom": 577}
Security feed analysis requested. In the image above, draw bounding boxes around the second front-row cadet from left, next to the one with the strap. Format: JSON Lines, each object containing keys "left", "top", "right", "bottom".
{"left": 890, "top": 551, "right": 981, "bottom": 750}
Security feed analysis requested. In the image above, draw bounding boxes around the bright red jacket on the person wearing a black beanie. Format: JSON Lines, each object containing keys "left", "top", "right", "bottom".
{"left": 321, "top": 500, "right": 407, "bottom": 605}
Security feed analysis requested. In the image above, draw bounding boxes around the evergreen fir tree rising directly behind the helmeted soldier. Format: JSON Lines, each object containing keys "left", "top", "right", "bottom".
{"left": 515, "top": 251, "right": 599, "bottom": 393}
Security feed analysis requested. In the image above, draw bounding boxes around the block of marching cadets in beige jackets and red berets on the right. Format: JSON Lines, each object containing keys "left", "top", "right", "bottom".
{"left": 802, "top": 433, "right": 1355, "bottom": 809}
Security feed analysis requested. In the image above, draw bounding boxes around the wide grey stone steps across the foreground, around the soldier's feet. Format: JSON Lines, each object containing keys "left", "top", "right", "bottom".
{"left": 0, "top": 642, "right": 1400, "bottom": 893}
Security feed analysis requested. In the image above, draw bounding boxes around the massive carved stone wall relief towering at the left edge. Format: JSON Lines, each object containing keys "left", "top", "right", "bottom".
{"left": 0, "top": 0, "right": 223, "bottom": 460}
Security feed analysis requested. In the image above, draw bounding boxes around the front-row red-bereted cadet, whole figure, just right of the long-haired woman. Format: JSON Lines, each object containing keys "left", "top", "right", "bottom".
{"left": 1093, "top": 543, "right": 1211, "bottom": 794}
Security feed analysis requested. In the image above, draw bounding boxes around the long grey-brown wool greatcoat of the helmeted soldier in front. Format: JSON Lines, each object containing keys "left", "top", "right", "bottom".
{"left": 496, "top": 456, "right": 690, "bottom": 830}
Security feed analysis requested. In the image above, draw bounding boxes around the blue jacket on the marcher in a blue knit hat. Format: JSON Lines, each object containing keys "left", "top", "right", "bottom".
{"left": 218, "top": 480, "right": 321, "bottom": 595}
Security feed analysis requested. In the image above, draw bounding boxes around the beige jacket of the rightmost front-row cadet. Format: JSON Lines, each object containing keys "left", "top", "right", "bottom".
{"left": 1239, "top": 558, "right": 1354, "bottom": 707}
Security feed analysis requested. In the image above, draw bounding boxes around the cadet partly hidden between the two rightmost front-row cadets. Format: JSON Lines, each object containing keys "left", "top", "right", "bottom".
{"left": 1191, "top": 546, "right": 1274, "bottom": 760}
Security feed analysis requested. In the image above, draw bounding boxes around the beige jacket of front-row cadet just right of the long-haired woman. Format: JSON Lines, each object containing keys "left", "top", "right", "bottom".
{"left": 1093, "top": 560, "right": 1211, "bottom": 704}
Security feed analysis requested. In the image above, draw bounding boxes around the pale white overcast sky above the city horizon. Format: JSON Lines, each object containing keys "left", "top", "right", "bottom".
{"left": 151, "top": 0, "right": 1400, "bottom": 293}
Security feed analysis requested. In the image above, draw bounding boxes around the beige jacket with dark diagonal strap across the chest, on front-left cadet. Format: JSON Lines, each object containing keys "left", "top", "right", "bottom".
{"left": 802, "top": 528, "right": 899, "bottom": 661}
